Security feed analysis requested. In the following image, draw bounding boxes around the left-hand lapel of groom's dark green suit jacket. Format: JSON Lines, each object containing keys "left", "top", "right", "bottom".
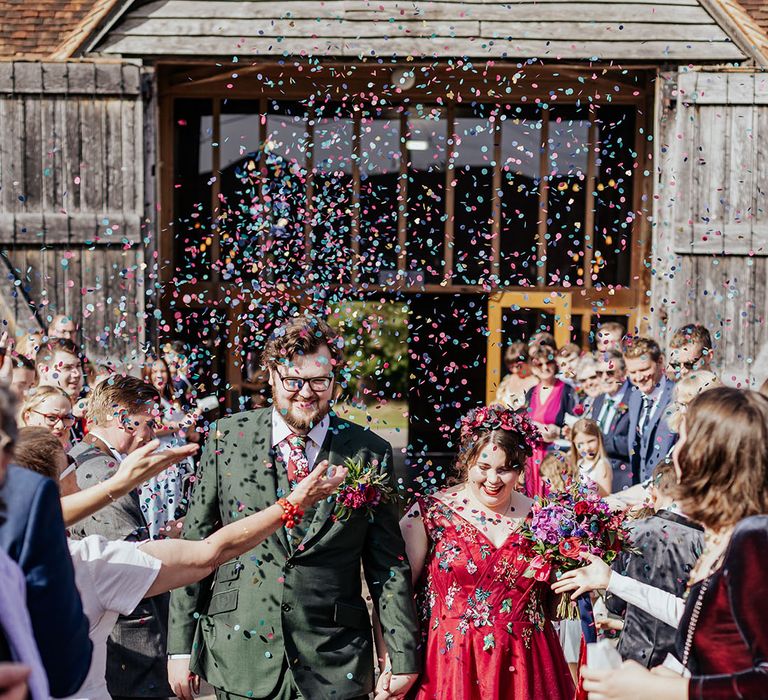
{"left": 242, "top": 408, "right": 290, "bottom": 556}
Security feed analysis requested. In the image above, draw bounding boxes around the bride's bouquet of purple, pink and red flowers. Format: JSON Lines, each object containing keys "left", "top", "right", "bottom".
{"left": 522, "top": 482, "right": 630, "bottom": 619}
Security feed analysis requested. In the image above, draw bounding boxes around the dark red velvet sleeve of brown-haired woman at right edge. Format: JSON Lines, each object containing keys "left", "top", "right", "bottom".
{"left": 688, "top": 516, "right": 768, "bottom": 700}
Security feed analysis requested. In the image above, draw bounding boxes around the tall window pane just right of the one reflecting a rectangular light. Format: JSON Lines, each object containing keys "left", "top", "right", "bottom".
{"left": 450, "top": 104, "right": 494, "bottom": 284}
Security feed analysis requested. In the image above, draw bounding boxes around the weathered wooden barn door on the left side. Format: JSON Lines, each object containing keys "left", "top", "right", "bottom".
{"left": 0, "top": 62, "right": 153, "bottom": 359}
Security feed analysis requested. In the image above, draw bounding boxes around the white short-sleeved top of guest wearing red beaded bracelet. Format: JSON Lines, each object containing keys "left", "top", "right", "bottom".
{"left": 62, "top": 535, "right": 161, "bottom": 700}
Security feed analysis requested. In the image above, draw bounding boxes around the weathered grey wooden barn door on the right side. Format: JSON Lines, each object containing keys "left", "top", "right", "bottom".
{"left": 652, "top": 72, "right": 768, "bottom": 383}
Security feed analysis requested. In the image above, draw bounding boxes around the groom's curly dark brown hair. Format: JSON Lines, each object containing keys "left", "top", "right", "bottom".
{"left": 261, "top": 315, "right": 344, "bottom": 369}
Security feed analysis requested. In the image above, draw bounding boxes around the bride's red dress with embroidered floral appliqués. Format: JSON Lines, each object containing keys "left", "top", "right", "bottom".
{"left": 414, "top": 497, "right": 574, "bottom": 700}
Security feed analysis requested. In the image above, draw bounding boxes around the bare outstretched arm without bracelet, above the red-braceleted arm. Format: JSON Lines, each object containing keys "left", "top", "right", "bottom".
{"left": 61, "top": 440, "right": 198, "bottom": 527}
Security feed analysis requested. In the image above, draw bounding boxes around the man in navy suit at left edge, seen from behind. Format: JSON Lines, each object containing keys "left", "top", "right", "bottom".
{"left": 0, "top": 387, "right": 93, "bottom": 697}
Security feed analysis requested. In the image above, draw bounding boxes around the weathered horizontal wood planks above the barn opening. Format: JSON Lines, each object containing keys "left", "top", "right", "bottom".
{"left": 92, "top": 0, "right": 744, "bottom": 61}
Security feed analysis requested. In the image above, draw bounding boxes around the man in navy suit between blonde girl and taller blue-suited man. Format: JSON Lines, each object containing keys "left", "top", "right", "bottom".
{"left": 592, "top": 350, "right": 634, "bottom": 493}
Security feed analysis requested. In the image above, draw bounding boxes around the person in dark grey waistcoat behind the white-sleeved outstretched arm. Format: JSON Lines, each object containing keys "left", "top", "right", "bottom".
{"left": 607, "top": 462, "right": 704, "bottom": 668}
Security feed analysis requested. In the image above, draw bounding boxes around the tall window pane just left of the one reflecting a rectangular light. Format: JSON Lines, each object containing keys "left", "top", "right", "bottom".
{"left": 360, "top": 111, "right": 400, "bottom": 284}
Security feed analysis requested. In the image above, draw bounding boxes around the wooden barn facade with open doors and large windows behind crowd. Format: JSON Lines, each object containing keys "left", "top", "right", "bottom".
{"left": 0, "top": 0, "right": 768, "bottom": 456}
